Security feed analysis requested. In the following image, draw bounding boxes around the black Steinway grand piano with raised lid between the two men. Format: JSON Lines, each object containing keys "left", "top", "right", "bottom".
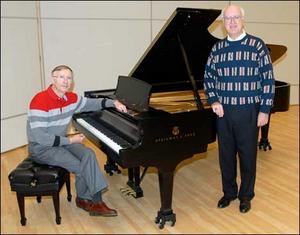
{"left": 73, "top": 8, "right": 290, "bottom": 228}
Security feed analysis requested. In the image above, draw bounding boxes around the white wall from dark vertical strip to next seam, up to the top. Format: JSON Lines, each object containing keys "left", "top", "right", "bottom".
{"left": 41, "top": 1, "right": 151, "bottom": 94}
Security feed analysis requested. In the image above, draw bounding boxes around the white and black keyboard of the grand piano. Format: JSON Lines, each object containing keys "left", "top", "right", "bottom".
{"left": 76, "top": 118, "right": 128, "bottom": 154}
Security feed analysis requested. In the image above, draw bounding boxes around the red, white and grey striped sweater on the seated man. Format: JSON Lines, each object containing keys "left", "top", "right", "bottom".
{"left": 27, "top": 86, "right": 114, "bottom": 147}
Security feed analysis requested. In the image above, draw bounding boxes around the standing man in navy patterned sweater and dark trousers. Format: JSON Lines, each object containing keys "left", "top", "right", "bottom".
{"left": 204, "top": 5, "right": 275, "bottom": 213}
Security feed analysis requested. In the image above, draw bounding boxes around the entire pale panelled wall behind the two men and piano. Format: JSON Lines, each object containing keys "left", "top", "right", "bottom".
{"left": 1, "top": 1, "right": 299, "bottom": 152}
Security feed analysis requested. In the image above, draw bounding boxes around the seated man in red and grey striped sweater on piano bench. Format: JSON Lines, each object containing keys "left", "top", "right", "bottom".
{"left": 27, "top": 65, "right": 127, "bottom": 216}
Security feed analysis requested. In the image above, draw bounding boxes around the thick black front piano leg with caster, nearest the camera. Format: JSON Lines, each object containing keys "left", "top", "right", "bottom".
{"left": 155, "top": 171, "right": 176, "bottom": 229}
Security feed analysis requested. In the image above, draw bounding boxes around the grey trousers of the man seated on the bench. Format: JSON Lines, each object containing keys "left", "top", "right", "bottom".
{"left": 28, "top": 143, "right": 107, "bottom": 200}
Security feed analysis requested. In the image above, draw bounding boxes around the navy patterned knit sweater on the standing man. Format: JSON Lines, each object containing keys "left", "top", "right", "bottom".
{"left": 204, "top": 34, "right": 275, "bottom": 113}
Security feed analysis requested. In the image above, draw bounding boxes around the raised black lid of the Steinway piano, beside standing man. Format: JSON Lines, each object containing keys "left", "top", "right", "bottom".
{"left": 129, "top": 8, "right": 221, "bottom": 92}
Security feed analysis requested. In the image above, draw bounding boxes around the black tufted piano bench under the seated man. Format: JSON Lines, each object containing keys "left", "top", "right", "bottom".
{"left": 8, "top": 157, "right": 72, "bottom": 226}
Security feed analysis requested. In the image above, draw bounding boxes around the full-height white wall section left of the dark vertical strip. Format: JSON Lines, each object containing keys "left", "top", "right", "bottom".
{"left": 1, "top": 1, "right": 42, "bottom": 152}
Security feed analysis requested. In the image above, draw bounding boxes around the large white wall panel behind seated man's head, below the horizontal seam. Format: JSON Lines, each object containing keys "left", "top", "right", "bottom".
{"left": 42, "top": 19, "right": 150, "bottom": 94}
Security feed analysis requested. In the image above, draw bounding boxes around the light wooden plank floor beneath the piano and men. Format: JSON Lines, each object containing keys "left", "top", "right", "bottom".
{"left": 1, "top": 106, "right": 299, "bottom": 234}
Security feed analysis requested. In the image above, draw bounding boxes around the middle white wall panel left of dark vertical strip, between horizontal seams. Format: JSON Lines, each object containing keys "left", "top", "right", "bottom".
{"left": 1, "top": 18, "right": 41, "bottom": 118}
